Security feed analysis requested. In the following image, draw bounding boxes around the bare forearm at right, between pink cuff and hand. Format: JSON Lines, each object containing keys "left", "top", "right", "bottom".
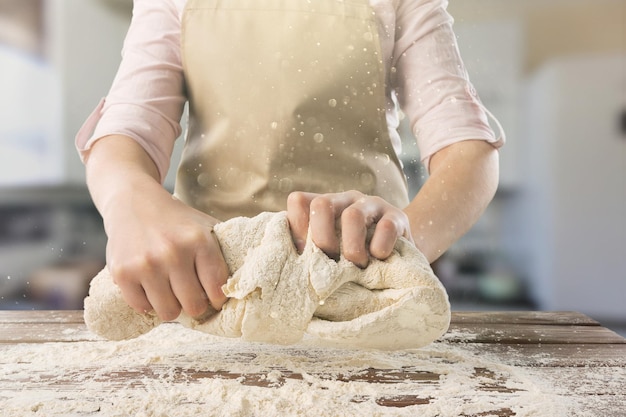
{"left": 404, "top": 140, "right": 498, "bottom": 262}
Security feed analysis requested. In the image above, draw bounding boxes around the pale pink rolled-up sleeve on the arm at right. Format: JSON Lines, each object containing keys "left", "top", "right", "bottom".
{"left": 391, "top": 0, "right": 504, "bottom": 171}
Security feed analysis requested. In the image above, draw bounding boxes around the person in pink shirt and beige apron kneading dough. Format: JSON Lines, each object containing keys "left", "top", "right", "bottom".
{"left": 76, "top": 0, "right": 503, "bottom": 320}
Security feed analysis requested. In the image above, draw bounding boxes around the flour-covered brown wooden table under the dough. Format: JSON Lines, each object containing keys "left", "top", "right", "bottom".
{"left": 0, "top": 311, "right": 626, "bottom": 417}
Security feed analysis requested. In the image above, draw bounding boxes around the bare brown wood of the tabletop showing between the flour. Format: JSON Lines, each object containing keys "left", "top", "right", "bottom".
{"left": 0, "top": 311, "right": 626, "bottom": 417}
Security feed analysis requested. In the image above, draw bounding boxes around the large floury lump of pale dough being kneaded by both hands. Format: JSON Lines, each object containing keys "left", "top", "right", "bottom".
{"left": 85, "top": 212, "right": 450, "bottom": 349}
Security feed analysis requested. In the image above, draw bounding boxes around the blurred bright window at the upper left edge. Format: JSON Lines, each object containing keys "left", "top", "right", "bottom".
{"left": 0, "top": 0, "right": 63, "bottom": 186}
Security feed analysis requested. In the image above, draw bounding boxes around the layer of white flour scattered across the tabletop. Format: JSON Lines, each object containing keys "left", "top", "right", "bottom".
{"left": 0, "top": 323, "right": 585, "bottom": 417}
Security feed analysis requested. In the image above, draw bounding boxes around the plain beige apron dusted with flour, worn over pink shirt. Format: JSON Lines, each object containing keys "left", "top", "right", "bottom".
{"left": 176, "top": 0, "right": 408, "bottom": 220}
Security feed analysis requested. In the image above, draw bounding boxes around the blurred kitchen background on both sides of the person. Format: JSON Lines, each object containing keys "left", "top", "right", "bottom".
{"left": 0, "top": 0, "right": 626, "bottom": 331}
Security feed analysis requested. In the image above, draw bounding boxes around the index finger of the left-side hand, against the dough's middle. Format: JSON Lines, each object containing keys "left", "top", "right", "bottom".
{"left": 195, "top": 231, "right": 228, "bottom": 310}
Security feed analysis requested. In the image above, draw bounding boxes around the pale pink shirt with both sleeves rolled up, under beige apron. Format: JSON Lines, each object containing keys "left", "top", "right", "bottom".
{"left": 76, "top": 0, "right": 504, "bottom": 184}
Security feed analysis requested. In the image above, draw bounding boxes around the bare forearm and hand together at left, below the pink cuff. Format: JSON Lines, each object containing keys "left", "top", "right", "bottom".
{"left": 87, "top": 137, "right": 228, "bottom": 321}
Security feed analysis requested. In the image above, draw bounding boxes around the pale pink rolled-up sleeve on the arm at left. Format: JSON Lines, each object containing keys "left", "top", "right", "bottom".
{"left": 75, "top": 0, "right": 186, "bottom": 181}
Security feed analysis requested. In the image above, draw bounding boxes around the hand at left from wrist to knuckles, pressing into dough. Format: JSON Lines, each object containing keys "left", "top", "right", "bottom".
{"left": 106, "top": 184, "right": 228, "bottom": 321}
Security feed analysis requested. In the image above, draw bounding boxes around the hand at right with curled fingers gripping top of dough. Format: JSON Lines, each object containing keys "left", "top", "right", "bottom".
{"left": 287, "top": 191, "right": 413, "bottom": 268}
